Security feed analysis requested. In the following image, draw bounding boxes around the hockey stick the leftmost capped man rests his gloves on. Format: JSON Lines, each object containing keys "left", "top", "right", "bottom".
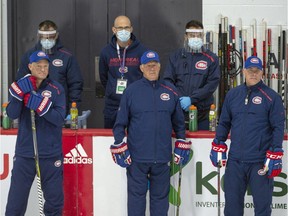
{"left": 30, "top": 109, "right": 44, "bottom": 216}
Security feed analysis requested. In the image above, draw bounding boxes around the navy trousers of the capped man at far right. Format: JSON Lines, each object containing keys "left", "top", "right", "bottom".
{"left": 224, "top": 160, "right": 273, "bottom": 216}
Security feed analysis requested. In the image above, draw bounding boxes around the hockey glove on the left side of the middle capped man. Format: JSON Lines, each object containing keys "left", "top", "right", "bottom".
{"left": 110, "top": 142, "right": 132, "bottom": 168}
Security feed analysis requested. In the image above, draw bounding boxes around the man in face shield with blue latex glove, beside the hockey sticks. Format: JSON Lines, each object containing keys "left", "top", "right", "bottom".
{"left": 164, "top": 20, "right": 220, "bottom": 130}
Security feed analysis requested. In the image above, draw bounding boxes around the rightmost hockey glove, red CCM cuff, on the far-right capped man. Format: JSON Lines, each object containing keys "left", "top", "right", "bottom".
{"left": 263, "top": 148, "right": 283, "bottom": 178}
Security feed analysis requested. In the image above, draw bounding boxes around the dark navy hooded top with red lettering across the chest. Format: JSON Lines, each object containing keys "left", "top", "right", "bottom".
{"left": 99, "top": 34, "right": 147, "bottom": 118}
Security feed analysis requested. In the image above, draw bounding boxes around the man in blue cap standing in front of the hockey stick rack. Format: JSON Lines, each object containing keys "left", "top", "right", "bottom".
{"left": 210, "top": 56, "right": 285, "bottom": 216}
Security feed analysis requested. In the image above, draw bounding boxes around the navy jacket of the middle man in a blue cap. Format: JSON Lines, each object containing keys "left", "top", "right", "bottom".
{"left": 113, "top": 77, "right": 185, "bottom": 163}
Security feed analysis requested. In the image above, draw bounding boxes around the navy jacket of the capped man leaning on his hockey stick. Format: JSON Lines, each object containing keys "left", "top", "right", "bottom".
{"left": 7, "top": 78, "right": 66, "bottom": 158}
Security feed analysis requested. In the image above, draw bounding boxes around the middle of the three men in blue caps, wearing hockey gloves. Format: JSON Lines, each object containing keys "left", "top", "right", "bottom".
{"left": 111, "top": 51, "right": 191, "bottom": 216}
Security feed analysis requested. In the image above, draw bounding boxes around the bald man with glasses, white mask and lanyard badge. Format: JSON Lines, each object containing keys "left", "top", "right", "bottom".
{"left": 99, "top": 15, "right": 147, "bottom": 128}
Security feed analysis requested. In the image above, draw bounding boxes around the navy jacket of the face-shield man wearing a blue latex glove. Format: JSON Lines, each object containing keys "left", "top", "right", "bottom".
{"left": 163, "top": 48, "right": 220, "bottom": 111}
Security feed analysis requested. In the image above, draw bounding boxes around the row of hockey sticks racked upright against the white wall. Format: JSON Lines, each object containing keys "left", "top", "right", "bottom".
{"left": 205, "top": 17, "right": 287, "bottom": 93}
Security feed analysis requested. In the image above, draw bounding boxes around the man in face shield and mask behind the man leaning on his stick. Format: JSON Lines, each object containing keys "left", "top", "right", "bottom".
{"left": 16, "top": 20, "right": 83, "bottom": 115}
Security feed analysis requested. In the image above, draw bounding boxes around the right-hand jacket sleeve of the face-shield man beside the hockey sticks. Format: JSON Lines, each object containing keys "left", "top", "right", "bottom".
{"left": 190, "top": 57, "right": 220, "bottom": 102}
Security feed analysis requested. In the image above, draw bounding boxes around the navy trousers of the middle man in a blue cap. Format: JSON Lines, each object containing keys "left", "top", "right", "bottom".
{"left": 127, "top": 161, "right": 170, "bottom": 216}
